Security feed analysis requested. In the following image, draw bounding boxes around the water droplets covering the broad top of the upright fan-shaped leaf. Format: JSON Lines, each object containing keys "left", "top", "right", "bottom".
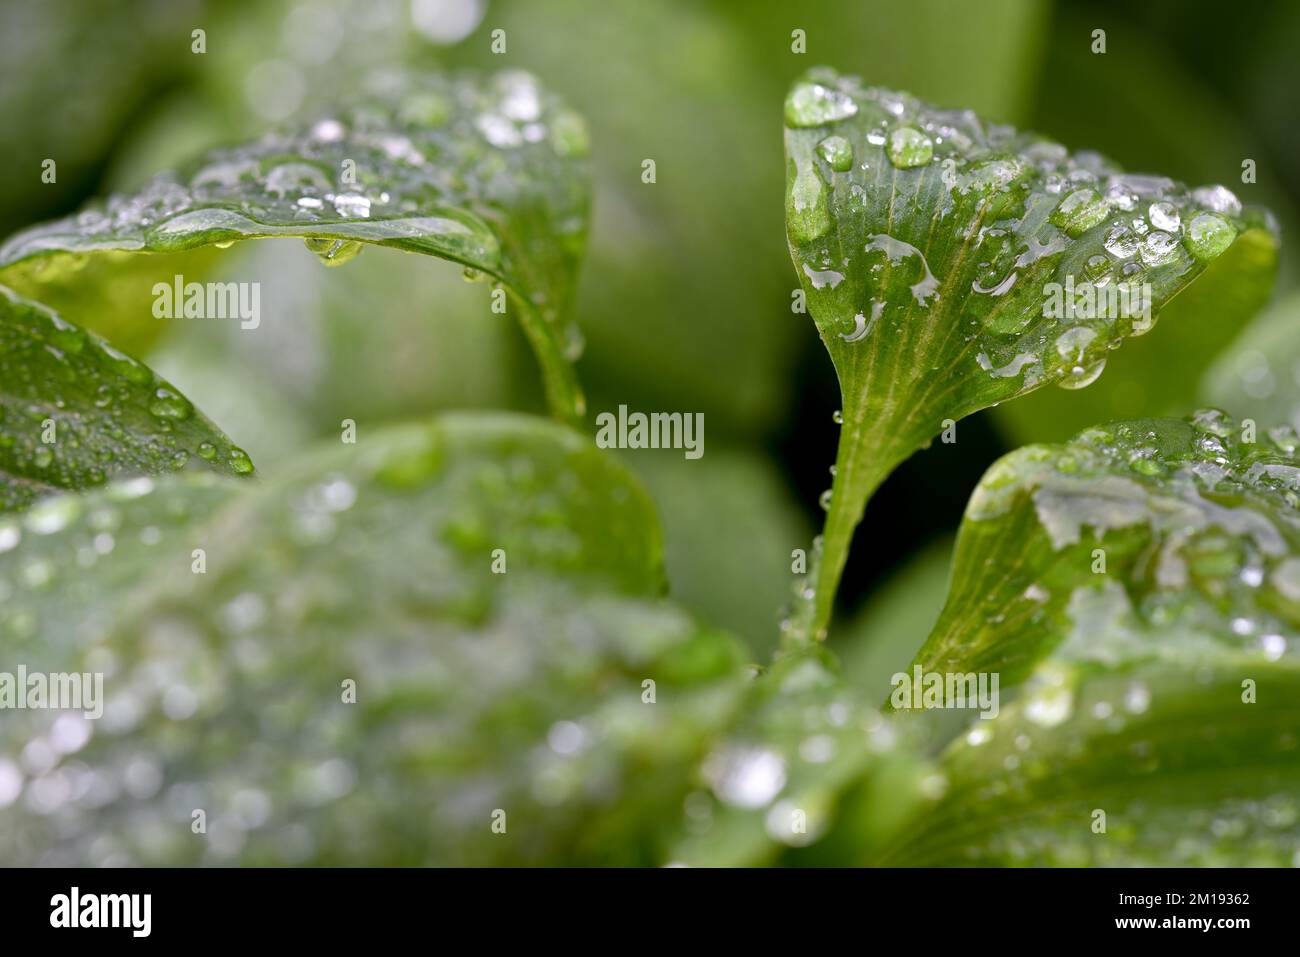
{"left": 785, "top": 69, "right": 1275, "bottom": 398}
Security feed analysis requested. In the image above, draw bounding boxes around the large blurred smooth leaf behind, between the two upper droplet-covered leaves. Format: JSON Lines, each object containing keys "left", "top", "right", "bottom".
{"left": 437, "top": 0, "right": 1048, "bottom": 438}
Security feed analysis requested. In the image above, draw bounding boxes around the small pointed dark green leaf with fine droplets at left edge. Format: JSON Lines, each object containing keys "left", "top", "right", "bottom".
{"left": 0, "top": 286, "right": 252, "bottom": 511}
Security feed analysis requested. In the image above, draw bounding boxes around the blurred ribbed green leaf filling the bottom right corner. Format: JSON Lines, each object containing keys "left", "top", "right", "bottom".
{"left": 874, "top": 655, "right": 1300, "bottom": 867}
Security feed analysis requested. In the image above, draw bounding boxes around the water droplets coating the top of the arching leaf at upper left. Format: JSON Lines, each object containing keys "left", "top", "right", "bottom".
{"left": 0, "top": 70, "right": 588, "bottom": 282}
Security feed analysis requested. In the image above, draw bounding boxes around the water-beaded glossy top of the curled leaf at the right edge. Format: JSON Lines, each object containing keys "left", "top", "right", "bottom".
{"left": 967, "top": 410, "right": 1300, "bottom": 661}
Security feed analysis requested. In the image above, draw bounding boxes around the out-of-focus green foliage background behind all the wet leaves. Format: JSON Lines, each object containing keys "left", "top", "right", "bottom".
{"left": 0, "top": 0, "right": 1300, "bottom": 862}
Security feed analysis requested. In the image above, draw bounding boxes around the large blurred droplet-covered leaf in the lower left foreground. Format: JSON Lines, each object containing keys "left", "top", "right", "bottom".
{"left": 0, "top": 413, "right": 744, "bottom": 865}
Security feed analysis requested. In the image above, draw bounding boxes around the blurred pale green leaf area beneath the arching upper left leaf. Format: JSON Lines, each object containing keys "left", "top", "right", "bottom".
{"left": 150, "top": 239, "right": 542, "bottom": 469}
